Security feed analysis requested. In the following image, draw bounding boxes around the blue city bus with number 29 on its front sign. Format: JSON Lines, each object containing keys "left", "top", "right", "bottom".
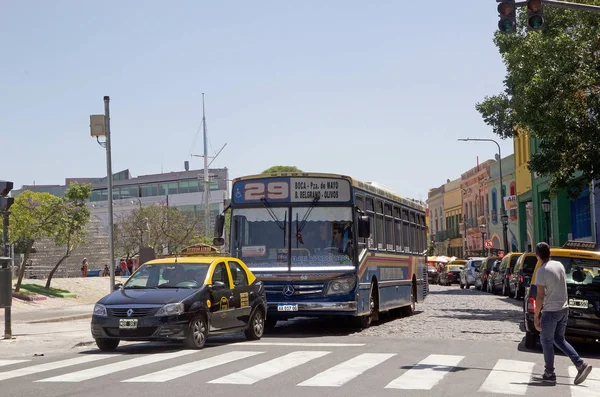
{"left": 214, "top": 173, "right": 429, "bottom": 328}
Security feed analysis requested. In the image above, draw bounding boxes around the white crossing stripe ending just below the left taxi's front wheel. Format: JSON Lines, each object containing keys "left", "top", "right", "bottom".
{"left": 37, "top": 350, "right": 197, "bottom": 382}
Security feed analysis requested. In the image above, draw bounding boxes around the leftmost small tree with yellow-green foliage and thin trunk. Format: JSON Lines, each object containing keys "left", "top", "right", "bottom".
{"left": 9, "top": 190, "right": 62, "bottom": 292}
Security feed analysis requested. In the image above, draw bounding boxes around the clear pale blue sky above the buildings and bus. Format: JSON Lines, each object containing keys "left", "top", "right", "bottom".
{"left": 0, "top": 0, "right": 512, "bottom": 199}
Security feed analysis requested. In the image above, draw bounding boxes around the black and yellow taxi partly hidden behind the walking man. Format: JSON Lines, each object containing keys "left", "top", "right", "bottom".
{"left": 523, "top": 241, "right": 600, "bottom": 349}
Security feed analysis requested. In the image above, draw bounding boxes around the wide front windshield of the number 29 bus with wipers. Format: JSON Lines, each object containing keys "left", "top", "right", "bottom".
{"left": 231, "top": 206, "right": 354, "bottom": 270}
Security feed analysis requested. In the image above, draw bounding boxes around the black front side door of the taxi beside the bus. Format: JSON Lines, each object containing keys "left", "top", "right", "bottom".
{"left": 210, "top": 262, "right": 235, "bottom": 331}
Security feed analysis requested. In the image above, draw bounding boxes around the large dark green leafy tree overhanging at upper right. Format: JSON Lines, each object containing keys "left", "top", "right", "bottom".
{"left": 476, "top": 5, "right": 600, "bottom": 197}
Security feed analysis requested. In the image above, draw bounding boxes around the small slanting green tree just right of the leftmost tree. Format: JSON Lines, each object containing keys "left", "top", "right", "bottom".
{"left": 46, "top": 183, "right": 92, "bottom": 288}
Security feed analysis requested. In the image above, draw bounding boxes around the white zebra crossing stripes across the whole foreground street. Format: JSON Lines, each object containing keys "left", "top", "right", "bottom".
{"left": 0, "top": 349, "right": 600, "bottom": 397}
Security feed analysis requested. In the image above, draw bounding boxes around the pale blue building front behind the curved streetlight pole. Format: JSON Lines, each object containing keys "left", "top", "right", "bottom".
{"left": 486, "top": 154, "right": 520, "bottom": 253}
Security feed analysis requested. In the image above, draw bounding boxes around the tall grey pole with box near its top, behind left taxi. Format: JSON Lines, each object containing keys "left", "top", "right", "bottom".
{"left": 90, "top": 96, "right": 115, "bottom": 292}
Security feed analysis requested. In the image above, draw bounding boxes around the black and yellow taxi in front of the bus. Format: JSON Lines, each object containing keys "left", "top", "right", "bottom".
{"left": 91, "top": 245, "right": 267, "bottom": 351}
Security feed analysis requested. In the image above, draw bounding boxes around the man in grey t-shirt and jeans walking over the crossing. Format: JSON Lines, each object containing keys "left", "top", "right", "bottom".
{"left": 534, "top": 243, "right": 592, "bottom": 385}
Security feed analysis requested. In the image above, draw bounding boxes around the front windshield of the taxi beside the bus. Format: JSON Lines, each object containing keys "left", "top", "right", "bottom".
{"left": 123, "top": 263, "right": 209, "bottom": 289}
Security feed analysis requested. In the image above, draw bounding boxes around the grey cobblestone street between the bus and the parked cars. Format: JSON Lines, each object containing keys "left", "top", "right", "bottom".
{"left": 361, "top": 285, "right": 524, "bottom": 342}
